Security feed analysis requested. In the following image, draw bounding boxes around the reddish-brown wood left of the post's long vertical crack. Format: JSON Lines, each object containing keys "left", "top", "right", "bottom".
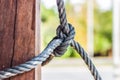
{"left": 0, "top": 0, "right": 16, "bottom": 80}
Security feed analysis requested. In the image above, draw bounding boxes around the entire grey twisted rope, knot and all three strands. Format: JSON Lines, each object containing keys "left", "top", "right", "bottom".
{"left": 0, "top": 0, "right": 102, "bottom": 80}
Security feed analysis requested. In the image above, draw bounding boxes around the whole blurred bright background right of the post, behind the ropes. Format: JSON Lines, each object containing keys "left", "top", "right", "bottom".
{"left": 41, "top": 0, "right": 120, "bottom": 80}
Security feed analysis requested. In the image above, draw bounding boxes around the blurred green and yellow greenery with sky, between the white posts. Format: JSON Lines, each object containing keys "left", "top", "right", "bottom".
{"left": 41, "top": 0, "right": 112, "bottom": 58}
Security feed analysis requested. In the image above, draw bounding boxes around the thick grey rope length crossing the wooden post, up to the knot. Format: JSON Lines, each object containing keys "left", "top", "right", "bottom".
{"left": 0, "top": 39, "right": 62, "bottom": 80}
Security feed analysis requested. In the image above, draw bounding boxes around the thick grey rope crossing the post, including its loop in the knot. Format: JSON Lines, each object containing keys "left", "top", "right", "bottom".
{"left": 0, "top": 25, "right": 75, "bottom": 80}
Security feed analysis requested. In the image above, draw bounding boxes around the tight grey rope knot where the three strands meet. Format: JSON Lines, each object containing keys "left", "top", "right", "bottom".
{"left": 53, "top": 24, "right": 75, "bottom": 57}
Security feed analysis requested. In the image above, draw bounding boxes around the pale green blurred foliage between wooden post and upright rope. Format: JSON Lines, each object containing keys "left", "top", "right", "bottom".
{"left": 41, "top": 5, "right": 59, "bottom": 47}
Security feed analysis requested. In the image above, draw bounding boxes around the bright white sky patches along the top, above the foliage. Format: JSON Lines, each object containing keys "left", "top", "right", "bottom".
{"left": 42, "top": 0, "right": 112, "bottom": 10}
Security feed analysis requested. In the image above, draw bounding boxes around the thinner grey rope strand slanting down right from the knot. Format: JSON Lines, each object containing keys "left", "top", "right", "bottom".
{"left": 71, "top": 40, "right": 102, "bottom": 80}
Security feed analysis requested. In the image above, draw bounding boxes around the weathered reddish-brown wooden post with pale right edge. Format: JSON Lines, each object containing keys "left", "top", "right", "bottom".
{"left": 0, "top": 0, "right": 40, "bottom": 80}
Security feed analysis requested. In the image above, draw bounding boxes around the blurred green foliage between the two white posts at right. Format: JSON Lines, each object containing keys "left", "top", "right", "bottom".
{"left": 94, "top": 8, "right": 112, "bottom": 55}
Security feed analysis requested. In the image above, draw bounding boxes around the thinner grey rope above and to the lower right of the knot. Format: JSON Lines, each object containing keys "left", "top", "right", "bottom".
{"left": 57, "top": 0, "right": 102, "bottom": 80}
